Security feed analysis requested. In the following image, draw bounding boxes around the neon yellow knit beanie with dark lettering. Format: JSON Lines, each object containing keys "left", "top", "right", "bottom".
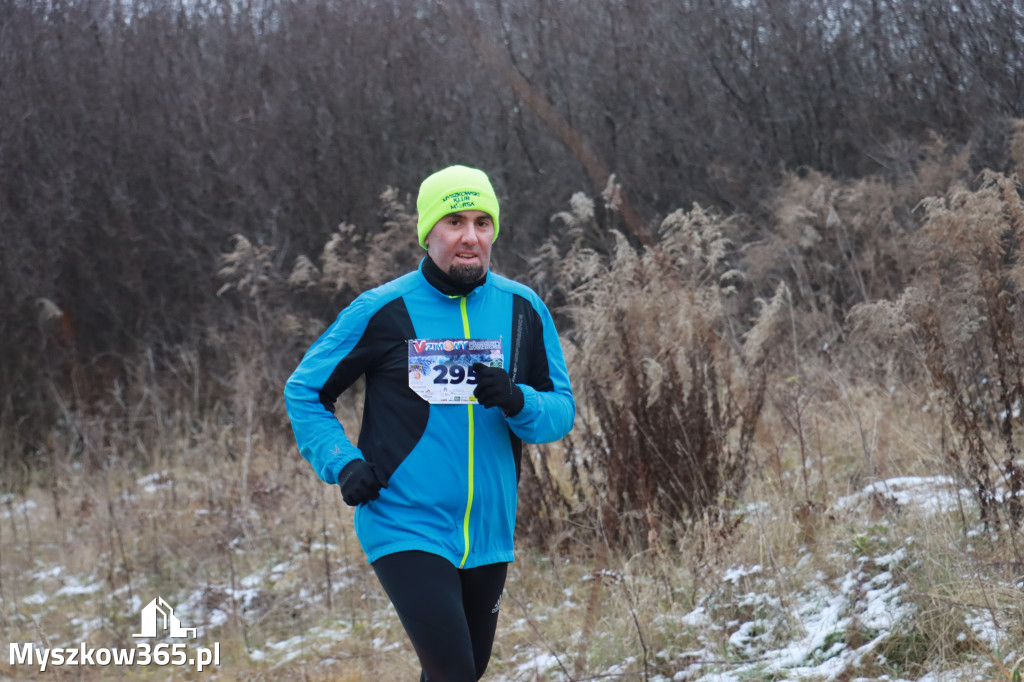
{"left": 416, "top": 166, "right": 498, "bottom": 249}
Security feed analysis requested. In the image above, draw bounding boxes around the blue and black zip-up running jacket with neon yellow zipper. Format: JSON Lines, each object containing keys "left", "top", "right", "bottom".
{"left": 285, "top": 258, "right": 575, "bottom": 568}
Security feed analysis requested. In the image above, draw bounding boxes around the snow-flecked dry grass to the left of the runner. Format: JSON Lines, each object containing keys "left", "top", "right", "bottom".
{"left": 0, "top": 405, "right": 412, "bottom": 679}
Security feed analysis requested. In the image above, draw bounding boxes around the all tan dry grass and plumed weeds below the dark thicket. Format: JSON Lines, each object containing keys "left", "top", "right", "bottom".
{"left": 0, "top": 135, "right": 1024, "bottom": 682}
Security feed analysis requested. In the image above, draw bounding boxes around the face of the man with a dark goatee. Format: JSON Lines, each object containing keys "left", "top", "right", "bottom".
{"left": 425, "top": 211, "right": 495, "bottom": 284}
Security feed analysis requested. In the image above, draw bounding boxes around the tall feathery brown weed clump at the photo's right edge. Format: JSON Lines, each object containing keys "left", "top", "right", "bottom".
{"left": 850, "top": 171, "right": 1024, "bottom": 548}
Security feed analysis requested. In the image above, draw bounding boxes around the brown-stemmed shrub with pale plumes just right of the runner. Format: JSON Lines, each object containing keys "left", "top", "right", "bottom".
{"left": 535, "top": 191, "right": 784, "bottom": 546}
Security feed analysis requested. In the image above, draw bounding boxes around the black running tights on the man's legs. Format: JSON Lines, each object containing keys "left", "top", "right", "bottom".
{"left": 373, "top": 552, "right": 508, "bottom": 682}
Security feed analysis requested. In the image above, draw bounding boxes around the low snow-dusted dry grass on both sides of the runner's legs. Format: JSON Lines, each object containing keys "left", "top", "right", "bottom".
{"left": 6, "top": 339, "right": 1024, "bottom": 681}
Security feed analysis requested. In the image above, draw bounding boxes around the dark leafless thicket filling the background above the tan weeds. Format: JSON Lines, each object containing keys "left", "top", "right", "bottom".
{"left": 0, "top": 0, "right": 1024, "bottom": 473}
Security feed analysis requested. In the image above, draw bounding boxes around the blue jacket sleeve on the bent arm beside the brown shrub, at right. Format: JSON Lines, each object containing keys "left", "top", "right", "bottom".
{"left": 508, "top": 298, "right": 575, "bottom": 443}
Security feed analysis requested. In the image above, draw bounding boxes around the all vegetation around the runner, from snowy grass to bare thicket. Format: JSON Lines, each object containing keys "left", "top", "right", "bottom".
{"left": 0, "top": 0, "right": 1024, "bottom": 682}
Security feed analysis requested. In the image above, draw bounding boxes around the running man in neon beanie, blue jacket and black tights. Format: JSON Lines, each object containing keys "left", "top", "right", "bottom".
{"left": 285, "top": 166, "right": 575, "bottom": 682}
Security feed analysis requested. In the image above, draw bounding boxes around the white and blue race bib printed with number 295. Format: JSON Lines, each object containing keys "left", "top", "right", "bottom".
{"left": 409, "top": 339, "right": 504, "bottom": 404}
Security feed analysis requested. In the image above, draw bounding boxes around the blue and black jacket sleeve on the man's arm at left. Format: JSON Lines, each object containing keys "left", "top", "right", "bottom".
{"left": 285, "top": 297, "right": 373, "bottom": 483}
